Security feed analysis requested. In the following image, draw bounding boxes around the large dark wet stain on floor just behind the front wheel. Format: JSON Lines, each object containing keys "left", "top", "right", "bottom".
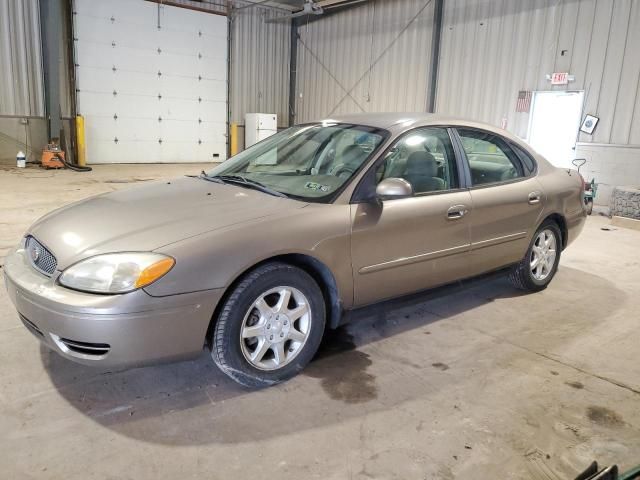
{"left": 304, "top": 327, "right": 378, "bottom": 403}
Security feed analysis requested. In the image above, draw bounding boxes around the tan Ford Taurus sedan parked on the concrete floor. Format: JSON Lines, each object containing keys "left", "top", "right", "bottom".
{"left": 4, "top": 114, "right": 586, "bottom": 386}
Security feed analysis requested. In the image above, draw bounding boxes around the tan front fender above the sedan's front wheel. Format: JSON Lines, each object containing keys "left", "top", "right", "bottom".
{"left": 145, "top": 204, "right": 353, "bottom": 308}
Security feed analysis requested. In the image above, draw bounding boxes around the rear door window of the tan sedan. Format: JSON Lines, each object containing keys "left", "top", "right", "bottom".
{"left": 458, "top": 129, "right": 525, "bottom": 185}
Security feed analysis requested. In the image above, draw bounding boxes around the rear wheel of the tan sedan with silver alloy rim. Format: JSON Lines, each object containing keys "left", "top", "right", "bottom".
{"left": 509, "top": 220, "right": 562, "bottom": 292}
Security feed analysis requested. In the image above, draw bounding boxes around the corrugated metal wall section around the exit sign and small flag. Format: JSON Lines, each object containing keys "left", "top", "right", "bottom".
{"left": 437, "top": 0, "right": 640, "bottom": 144}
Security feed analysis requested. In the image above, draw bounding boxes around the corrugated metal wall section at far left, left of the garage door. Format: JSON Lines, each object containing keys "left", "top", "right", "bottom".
{"left": 0, "top": 0, "right": 44, "bottom": 117}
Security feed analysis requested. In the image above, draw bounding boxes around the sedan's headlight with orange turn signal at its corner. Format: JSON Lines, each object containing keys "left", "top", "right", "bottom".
{"left": 59, "top": 252, "right": 175, "bottom": 293}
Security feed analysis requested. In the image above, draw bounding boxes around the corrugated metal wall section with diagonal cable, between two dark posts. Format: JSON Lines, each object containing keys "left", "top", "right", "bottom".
{"left": 296, "top": 0, "right": 433, "bottom": 122}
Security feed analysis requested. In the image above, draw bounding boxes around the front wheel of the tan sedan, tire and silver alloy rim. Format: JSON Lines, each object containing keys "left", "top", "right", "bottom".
{"left": 211, "top": 262, "right": 326, "bottom": 388}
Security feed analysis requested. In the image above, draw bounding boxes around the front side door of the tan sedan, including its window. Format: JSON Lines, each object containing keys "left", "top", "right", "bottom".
{"left": 351, "top": 127, "right": 472, "bottom": 306}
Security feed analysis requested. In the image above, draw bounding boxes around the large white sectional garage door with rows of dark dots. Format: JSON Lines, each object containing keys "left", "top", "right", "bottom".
{"left": 74, "top": 0, "right": 227, "bottom": 163}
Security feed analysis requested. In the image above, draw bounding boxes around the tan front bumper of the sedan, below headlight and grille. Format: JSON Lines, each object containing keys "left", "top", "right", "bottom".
{"left": 4, "top": 248, "right": 223, "bottom": 367}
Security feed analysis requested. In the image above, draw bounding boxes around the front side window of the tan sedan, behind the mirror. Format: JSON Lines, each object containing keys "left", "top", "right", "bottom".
{"left": 376, "top": 128, "right": 459, "bottom": 194}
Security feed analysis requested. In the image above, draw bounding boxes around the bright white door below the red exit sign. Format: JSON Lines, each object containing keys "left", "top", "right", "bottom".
{"left": 528, "top": 91, "right": 584, "bottom": 168}
